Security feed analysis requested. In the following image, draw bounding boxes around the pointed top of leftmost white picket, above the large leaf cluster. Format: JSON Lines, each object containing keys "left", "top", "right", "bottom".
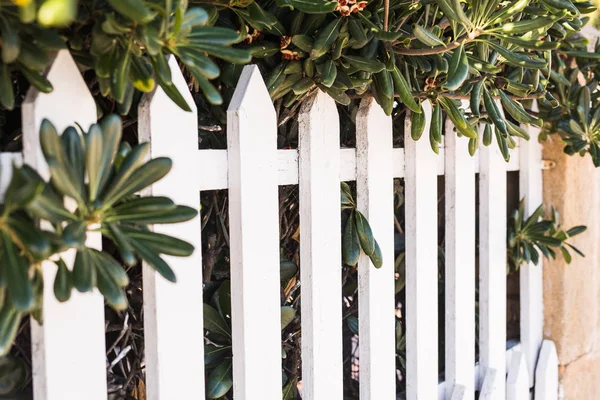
{"left": 22, "top": 50, "right": 97, "bottom": 179}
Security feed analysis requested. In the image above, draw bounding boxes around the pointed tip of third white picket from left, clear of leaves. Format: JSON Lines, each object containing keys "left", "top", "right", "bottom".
{"left": 227, "top": 65, "right": 275, "bottom": 118}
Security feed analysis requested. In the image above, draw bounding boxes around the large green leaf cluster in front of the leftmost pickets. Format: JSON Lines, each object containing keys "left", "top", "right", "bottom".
{"left": 0, "top": 116, "right": 197, "bottom": 357}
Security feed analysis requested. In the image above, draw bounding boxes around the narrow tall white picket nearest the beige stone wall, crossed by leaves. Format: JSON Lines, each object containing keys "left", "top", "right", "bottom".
{"left": 519, "top": 103, "right": 544, "bottom": 387}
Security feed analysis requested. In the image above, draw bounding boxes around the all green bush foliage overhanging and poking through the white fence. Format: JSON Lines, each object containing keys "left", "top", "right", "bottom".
{"left": 0, "top": 0, "right": 600, "bottom": 396}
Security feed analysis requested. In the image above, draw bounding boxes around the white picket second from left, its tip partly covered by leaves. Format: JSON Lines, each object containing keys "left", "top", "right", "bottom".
{"left": 138, "top": 57, "right": 204, "bottom": 400}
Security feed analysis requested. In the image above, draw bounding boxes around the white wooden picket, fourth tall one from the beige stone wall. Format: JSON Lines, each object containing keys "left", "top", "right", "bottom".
{"left": 404, "top": 101, "right": 438, "bottom": 400}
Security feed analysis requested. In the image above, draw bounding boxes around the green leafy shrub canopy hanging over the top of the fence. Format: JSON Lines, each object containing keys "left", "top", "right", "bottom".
{"left": 0, "top": 0, "right": 600, "bottom": 160}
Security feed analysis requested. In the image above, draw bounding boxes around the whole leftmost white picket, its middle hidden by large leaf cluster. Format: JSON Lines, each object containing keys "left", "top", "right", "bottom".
{"left": 22, "top": 50, "right": 107, "bottom": 400}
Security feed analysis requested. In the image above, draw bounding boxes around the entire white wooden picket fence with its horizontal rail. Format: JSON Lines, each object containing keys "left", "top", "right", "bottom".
{"left": 0, "top": 51, "right": 558, "bottom": 400}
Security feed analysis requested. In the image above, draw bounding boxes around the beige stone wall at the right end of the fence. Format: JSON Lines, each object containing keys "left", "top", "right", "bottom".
{"left": 543, "top": 135, "right": 600, "bottom": 400}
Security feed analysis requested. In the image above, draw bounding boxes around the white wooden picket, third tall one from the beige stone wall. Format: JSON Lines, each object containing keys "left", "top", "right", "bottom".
{"left": 445, "top": 113, "right": 475, "bottom": 400}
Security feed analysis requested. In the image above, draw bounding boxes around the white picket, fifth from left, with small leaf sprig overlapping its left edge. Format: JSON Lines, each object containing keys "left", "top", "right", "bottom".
{"left": 356, "top": 98, "right": 396, "bottom": 400}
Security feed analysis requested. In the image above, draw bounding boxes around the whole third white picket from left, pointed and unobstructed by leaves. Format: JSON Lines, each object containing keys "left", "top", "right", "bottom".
{"left": 227, "top": 66, "right": 282, "bottom": 400}
